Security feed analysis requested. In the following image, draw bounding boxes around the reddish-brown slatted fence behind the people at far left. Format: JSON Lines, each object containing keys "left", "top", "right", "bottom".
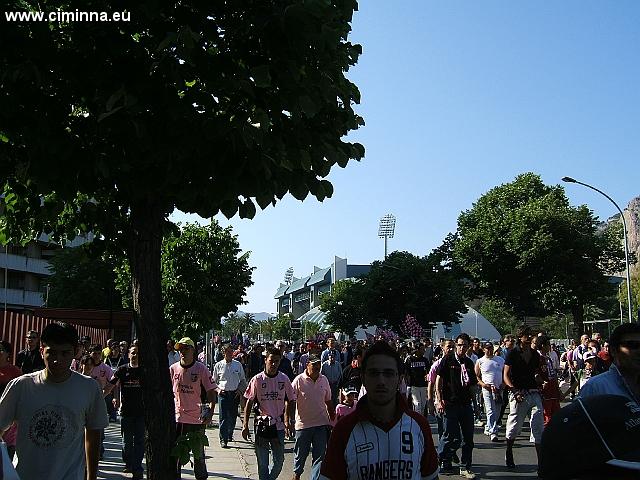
{"left": 0, "top": 311, "right": 109, "bottom": 361}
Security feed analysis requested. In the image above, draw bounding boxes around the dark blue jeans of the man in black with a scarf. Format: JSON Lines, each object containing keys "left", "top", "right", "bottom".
{"left": 438, "top": 403, "right": 473, "bottom": 468}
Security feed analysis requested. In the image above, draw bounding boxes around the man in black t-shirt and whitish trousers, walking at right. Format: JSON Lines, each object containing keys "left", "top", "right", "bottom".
{"left": 503, "top": 325, "right": 544, "bottom": 468}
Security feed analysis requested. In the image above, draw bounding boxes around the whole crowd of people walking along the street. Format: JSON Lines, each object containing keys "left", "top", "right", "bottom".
{"left": 0, "top": 323, "right": 640, "bottom": 480}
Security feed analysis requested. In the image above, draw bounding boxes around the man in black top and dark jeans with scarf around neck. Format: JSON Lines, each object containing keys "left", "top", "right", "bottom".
{"left": 435, "top": 333, "right": 478, "bottom": 479}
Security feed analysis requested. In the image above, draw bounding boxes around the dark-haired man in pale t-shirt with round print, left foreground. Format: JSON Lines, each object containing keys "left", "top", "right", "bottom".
{"left": 0, "top": 323, "right": 109, "bottom": 480}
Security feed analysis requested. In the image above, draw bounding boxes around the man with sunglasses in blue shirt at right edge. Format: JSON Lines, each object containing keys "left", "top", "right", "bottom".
{"left": 578, "top": 323, "right": 640, "bottom": 402}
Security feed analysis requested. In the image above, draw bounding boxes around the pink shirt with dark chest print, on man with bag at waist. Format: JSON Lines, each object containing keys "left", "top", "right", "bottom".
{"left": 244, "top": 372, "right": 296, "bottom": 430}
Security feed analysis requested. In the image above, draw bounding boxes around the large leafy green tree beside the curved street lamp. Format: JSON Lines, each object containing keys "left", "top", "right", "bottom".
{"left": 453, "top": 173, "right": 624, "bottom": 336}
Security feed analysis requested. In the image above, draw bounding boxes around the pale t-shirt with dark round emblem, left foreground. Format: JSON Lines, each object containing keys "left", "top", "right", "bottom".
{"left": 0, "top": 370, "right": 109, "bottom": 480}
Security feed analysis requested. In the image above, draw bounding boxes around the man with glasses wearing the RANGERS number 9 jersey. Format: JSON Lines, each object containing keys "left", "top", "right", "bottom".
{"left": 320, "top": 341, "right": 438, "bottom": 480}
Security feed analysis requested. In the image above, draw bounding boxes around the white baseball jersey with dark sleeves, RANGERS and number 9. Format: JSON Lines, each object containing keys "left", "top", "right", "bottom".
{"left": 320, "top": 394, "right": 438, "bottom": 480}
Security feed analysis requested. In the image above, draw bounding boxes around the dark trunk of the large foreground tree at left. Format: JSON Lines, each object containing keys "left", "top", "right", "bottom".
{"left": 129, "top": 201, "right": 177, "bottom": 480}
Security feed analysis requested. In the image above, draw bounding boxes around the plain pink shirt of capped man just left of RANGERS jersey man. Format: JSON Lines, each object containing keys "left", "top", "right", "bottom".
{"left": 292, "top": 372, "right": 331, "bottom": 430}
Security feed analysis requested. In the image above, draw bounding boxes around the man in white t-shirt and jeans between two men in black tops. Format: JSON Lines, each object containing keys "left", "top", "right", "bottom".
{"left": 475, "top": 342, "right": 504, "bottom": 442}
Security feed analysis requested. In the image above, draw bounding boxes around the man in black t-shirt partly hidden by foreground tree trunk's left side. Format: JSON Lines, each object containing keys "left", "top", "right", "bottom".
{"left": 104, "top": 345, "right": 144, "bottom": 479}
